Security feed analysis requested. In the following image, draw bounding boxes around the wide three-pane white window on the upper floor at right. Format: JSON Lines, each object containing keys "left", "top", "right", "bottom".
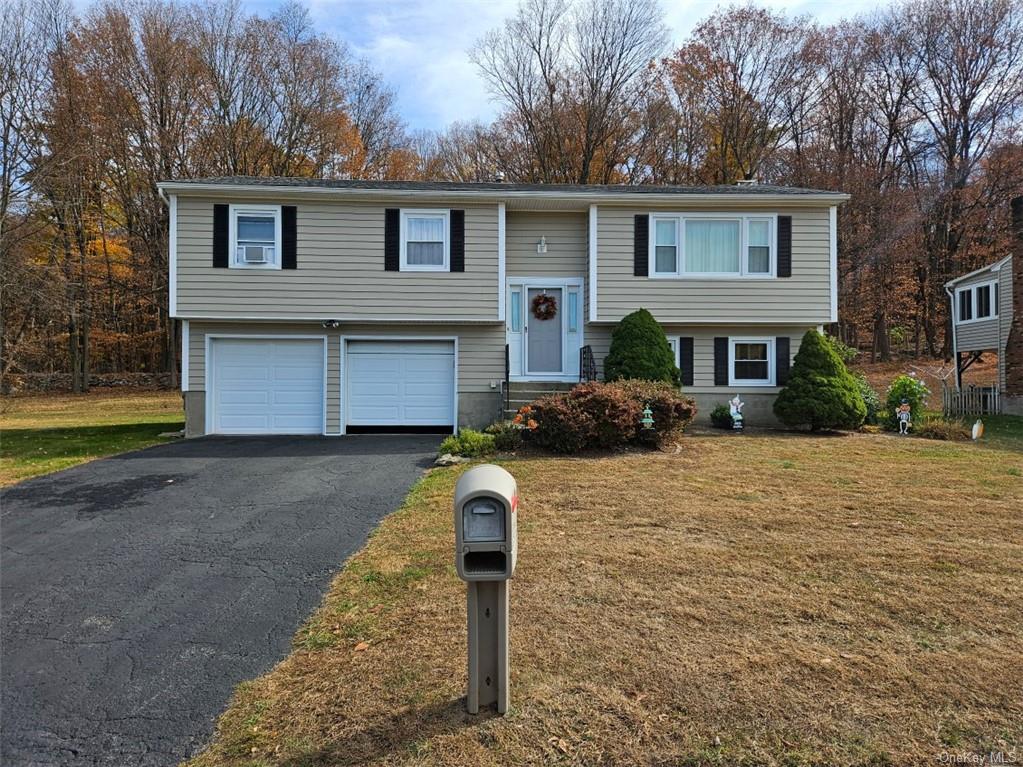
{"left": 651, "top": 214, "right": 774, "bottom": 277}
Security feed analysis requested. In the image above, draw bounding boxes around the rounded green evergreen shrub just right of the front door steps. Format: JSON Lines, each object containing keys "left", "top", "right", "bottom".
{"left": 604, "top": 309, "right": 682, "bottom": 387}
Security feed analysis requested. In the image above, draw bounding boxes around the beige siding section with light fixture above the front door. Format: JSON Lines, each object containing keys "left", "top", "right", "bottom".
{"left": 505, "top": 211, "right": 588, "bottom": 277}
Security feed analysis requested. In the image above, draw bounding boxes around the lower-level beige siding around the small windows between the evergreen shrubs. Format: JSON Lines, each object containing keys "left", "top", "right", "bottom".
{"left": 585, "top": 325, "right": 812, "bottom": 402}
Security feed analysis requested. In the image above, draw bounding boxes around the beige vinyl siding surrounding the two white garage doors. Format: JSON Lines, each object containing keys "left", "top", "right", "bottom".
{"left": 188, "top": 320, "right": 504, "bottom": 434}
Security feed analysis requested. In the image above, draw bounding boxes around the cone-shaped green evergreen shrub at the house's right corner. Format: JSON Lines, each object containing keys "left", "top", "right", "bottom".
{"left": 774, "top": 330, "right": 866, "bottom": 432}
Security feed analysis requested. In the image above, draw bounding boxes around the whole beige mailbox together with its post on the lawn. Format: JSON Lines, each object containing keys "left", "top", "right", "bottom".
{"left": 454, "top": 464, "right": 519, "bottom": 714}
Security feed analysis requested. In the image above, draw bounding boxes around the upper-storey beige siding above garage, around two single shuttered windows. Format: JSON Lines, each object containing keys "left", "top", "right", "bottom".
{"left": 177, "top": 196, "right": 497, "bottom": 321}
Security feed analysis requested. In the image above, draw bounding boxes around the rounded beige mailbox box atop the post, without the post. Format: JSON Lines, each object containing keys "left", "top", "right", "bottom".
{"left": 454, "top": 464, "right": 519, "bottom": 581}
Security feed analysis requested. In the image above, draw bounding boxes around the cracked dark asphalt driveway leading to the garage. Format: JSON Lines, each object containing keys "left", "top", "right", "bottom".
{"left": 0, "top": 436, "right": 439, "bottom": 767}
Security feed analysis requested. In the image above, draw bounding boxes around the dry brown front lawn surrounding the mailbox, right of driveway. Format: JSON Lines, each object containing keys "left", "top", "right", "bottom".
{"left": 193, "top": 435, "right": 1023, "bottom": 767}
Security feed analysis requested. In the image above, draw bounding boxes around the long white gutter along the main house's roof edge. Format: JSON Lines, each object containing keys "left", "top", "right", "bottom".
{"left": 157, "top": 181, "right": 850, "bottom": 206}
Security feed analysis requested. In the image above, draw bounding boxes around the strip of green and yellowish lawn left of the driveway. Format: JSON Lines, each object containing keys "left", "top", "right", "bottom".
{"left": 0, "top": 390, "right": 184, "bottom": 487}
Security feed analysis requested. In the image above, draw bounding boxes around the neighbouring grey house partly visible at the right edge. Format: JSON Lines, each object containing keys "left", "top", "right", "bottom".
{"left": 945, "top": 196, "right": 1023, "bottom": 415}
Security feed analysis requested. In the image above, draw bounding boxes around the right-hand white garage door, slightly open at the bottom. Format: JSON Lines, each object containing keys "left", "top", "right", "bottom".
{"left": 344, "top": 341, "right": 454, "bottom": 432}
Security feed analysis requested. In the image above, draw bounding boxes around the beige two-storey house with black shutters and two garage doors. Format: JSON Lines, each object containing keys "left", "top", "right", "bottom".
{"left": 153, "top": 178, "right": 847, "bottom": 436}
